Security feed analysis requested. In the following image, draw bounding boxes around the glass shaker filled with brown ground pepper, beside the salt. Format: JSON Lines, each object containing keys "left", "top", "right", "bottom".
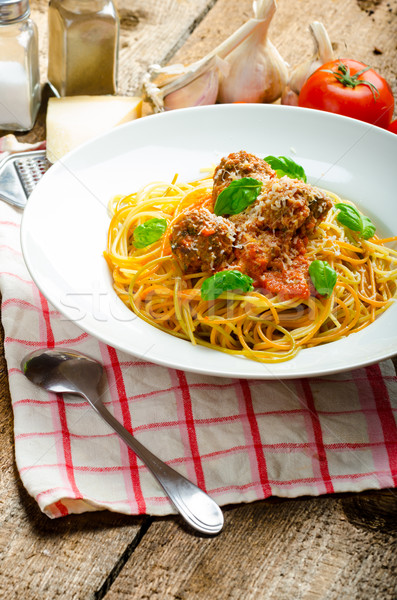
{"left": 48, "top": 0, "right": 120, "bottom": 96}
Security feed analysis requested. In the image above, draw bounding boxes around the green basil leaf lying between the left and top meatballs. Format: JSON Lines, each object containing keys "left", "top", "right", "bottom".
{"left": 214, "top": 177, "right": 263, "bottom": 216}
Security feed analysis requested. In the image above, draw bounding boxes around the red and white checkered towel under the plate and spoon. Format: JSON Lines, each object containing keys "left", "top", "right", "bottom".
{"left": 0, "top": 139, "right": 397, "bottom": 517}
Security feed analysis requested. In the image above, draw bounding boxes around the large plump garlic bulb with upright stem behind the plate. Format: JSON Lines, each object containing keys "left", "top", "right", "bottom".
{"left": 218, "top": 0, "right": 288, "bottom": 102}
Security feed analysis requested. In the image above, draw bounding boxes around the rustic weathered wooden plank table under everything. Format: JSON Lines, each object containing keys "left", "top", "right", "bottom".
{"left": 0, "top": 0, "right": 397, "bottom": 600}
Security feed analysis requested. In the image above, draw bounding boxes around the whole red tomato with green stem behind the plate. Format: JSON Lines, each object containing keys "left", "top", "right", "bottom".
{"left": 299, "top": 58, "right": 394, "bottom": 128}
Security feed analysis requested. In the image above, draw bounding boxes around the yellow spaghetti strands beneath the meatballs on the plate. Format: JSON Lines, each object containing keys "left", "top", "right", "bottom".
{"left": 104, "top": 152, "right": 397, "bottom": 363}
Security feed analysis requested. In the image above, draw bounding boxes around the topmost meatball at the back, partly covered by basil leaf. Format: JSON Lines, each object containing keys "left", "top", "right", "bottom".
{"left": 212, "top": 150, "right": 276, "bottom": 202}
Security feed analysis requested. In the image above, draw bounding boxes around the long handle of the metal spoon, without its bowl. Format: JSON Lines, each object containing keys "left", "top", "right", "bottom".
{"left": 84, "top": 390, "right": 223, "bottom": 534}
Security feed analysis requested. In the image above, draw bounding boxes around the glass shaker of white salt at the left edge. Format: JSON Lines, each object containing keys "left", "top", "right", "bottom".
{"left": 0, "top": 0, "right": 41, "bottom": 131}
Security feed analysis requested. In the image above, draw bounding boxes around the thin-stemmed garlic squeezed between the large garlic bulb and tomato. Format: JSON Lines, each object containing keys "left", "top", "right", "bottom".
{"left": 281, "top": 21, "right": 334, "bottom": 106}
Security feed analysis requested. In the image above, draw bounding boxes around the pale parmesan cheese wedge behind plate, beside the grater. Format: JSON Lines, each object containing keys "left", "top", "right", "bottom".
{"left": 47, "top": 96, "right": 142, "bottom": 163}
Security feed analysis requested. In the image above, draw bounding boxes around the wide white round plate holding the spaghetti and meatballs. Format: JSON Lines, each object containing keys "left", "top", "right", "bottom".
{"left": 21, "top": 104, "right": 397, "bottom": 379}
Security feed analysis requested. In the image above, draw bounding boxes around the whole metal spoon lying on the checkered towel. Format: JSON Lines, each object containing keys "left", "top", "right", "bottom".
{"left": 21, "top": 349, "right": 223, "bottom": 534}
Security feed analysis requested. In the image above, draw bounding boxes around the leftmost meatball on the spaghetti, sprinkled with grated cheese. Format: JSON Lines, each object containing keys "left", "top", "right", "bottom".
{"left": 170, "top": 208, "right": 235, "bottom": 273}
